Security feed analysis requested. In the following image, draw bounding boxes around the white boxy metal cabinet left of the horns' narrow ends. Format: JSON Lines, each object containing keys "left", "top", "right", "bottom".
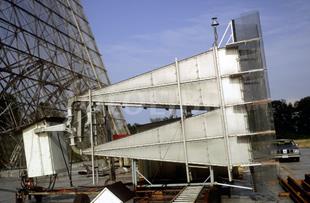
{"left": 23, "top": 120, "right": 68, "bottom": 177}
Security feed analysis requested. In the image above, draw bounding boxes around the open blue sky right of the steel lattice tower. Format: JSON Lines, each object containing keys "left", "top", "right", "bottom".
{"left": 82, "top": 0, "right": 310, "bottom": 122}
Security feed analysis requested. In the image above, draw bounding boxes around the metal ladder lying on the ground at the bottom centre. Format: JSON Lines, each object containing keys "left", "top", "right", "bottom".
{"left": 172, "top": 185, "right": 203, "bottom": 203}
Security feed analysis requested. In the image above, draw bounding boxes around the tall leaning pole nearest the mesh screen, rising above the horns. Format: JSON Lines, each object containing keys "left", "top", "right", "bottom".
{"left": 213, "top": 20, "right": 232, "bottom": 181}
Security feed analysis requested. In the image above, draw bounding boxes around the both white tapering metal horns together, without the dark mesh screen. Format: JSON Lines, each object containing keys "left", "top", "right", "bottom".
{"left": 74, "top": 48, "right": 273, "bottom": 166}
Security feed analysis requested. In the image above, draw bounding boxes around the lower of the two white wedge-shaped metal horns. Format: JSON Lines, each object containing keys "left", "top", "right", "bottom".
{"left": 84, "top": 107, "right": 249, "bottom": 166}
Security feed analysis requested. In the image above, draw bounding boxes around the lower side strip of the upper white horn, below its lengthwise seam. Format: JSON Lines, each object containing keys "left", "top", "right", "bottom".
{"left": 89, "top": 79, "right": 219, "bottom": 107}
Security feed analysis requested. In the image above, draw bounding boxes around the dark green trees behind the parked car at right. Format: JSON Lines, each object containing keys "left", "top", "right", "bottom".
{"left": 272, "top": 96, "right": 310, "bottom": 139}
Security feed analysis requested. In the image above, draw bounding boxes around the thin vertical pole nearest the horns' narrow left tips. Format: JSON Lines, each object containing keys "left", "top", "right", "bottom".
{"left": 88, "top": 90, "right": 96, "bottom": 185}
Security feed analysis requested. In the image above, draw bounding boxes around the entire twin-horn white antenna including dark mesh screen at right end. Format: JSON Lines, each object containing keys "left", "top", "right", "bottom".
{"left": 68, "top": 12, "right": 274, "bottom": 182}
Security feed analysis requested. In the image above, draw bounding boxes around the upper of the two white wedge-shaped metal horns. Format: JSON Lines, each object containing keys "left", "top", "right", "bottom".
{"left": 74, "top": 49, "right": 242, "bottom": 107}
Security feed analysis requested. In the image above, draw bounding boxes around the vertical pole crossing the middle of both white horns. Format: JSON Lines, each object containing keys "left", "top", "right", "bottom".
{"left": 175, "top": 58, "right": 190, "bottom": 183}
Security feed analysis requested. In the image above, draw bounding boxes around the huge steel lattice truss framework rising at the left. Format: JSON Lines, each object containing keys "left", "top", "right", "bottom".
{"left": 0, "top": 0, "right": 126, "bottom": 167}
